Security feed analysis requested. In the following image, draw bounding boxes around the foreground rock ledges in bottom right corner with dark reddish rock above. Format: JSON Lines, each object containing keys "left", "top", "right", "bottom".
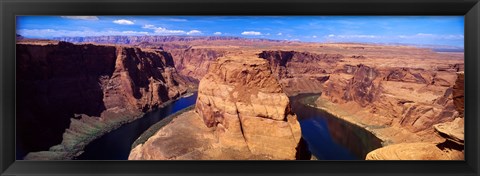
{"left": 366, "top": 69, "right": 465, "bottom": 160}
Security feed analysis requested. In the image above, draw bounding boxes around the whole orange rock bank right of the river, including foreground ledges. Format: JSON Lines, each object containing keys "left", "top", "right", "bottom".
{"left": 308, "top": 50, "right": 463, "bottom": 160}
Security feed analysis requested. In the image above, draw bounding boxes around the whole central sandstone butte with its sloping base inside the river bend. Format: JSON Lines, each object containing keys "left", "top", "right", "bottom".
{"left": 129, "top": 53, "right": 310, "bottom": 160}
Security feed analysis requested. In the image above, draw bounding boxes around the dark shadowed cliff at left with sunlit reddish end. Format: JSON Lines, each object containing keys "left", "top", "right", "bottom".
{"left": 16, "top": 42, "right": 187, "bottom": 159}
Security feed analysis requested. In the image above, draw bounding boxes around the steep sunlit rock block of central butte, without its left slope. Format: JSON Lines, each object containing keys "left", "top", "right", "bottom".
{"left": 195, "top": 55, "right": 301, "bottom": 159}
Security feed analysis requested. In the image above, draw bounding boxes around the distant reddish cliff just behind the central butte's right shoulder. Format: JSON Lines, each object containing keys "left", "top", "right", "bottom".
{"left": 258, "top": 51, "right": 343, "bottom": 96}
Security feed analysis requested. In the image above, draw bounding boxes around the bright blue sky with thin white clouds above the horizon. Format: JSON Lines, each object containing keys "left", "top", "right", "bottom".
{"left": 16, "top": 16, "right": 464, "bottom": 47}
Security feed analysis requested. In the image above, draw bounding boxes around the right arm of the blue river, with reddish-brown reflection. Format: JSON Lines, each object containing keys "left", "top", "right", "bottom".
{"left": 290, "top": 94, "right": 382, "bottom": 160}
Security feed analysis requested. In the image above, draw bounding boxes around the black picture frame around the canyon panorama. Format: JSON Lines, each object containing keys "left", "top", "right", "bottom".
{"left": 0, "top": 0, "right": 480, "bottom": 176}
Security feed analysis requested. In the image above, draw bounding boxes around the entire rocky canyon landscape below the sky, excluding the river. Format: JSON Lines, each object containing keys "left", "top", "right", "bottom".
{"left": 17, "top": 36, "right": 464, "bottom": 160}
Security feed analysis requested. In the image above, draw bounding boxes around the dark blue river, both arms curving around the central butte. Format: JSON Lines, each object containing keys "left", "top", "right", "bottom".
{"left": 75, "top": 93, "right": 381, "bottom": 160}
